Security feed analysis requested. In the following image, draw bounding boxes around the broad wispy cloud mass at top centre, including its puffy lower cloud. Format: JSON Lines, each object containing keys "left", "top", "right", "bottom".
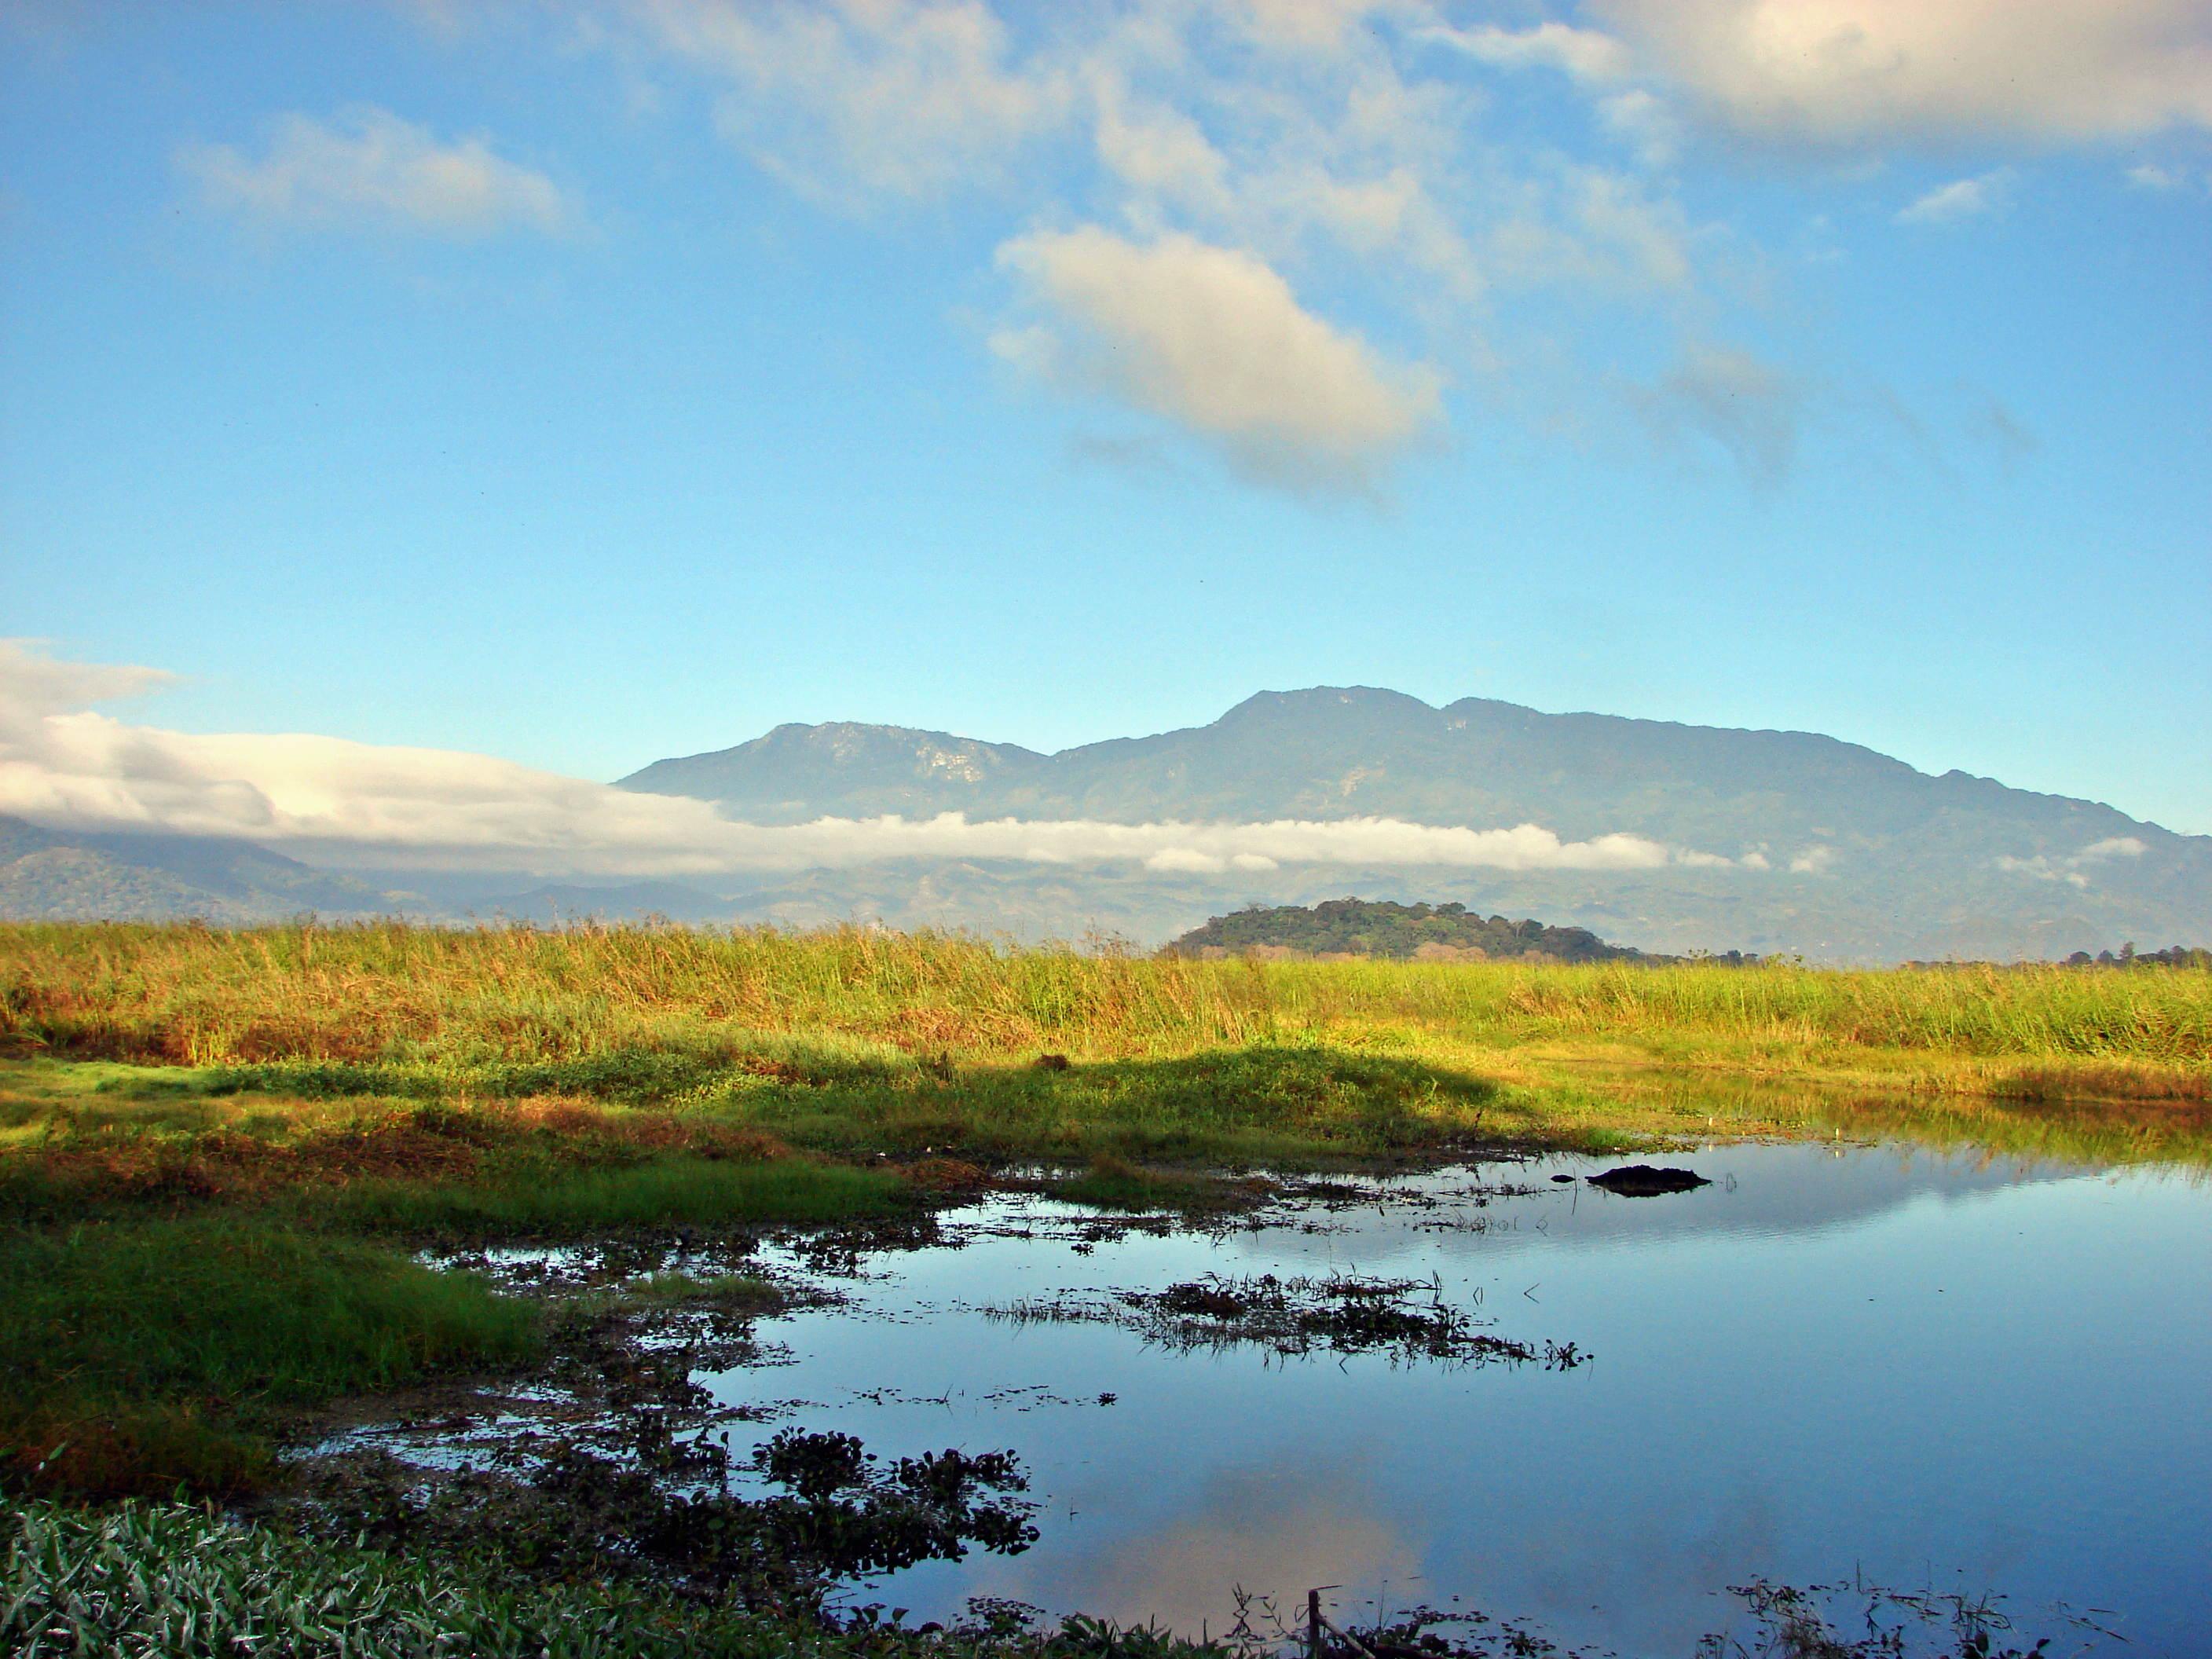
{"left": 584, "top": 0, "right": 1743, "bottom": 493}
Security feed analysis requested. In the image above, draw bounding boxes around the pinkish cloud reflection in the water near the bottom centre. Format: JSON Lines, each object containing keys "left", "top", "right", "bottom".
{"left": 993, "top": 1456, "right": 1420, "bottom": 1632}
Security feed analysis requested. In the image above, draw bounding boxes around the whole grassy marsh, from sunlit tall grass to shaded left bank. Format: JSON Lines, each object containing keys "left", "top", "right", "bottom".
{"left": 0, "top": 925, "right": 2212, "bottom": 1574}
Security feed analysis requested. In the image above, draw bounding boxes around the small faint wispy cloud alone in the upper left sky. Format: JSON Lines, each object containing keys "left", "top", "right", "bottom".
{"left": 177, "top": 108, "right": 580, "bottom": 236}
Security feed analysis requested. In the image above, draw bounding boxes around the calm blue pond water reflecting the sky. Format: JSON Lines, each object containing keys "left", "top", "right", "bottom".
{"left": 721, "top": 1146, "right": 2212, "bottom": 1654}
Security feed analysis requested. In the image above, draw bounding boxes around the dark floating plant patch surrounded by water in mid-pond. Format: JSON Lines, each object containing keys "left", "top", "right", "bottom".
{"left": 984, "top": 1274, "right": 1591, "bottom": 1372}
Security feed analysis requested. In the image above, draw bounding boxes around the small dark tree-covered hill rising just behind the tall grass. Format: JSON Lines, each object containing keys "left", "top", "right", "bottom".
{"left": 1163, "top": 898, "right": 1707, "bottom": 962}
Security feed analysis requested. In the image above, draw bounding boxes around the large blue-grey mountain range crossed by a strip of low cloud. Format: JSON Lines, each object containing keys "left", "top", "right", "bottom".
{"left": 621, "top": 688, "right": 2212, "bottom": 958}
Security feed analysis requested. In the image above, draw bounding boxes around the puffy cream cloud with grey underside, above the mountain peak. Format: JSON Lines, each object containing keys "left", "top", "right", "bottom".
{"left": 993, "top": 225, "right": 1442, "bottom": 489}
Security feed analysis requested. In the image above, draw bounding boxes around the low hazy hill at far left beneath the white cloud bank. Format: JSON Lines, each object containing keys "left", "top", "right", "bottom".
{"left": 0, "top": 816, "right": 420, "bottom": 922}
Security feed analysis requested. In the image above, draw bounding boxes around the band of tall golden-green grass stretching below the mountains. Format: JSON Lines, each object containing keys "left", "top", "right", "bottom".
{"left": 0, "top": 925, "right": 2212, "bottom": 1068}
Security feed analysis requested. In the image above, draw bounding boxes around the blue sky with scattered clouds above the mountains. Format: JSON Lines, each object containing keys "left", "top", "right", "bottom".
{"left": 0, "top": 0, "right": 2212, "bottom": 859}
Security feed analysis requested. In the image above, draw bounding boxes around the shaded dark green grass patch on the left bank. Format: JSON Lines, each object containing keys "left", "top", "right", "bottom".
{"left": 0, "top": 1214, "right": 540, "bottom": 1491}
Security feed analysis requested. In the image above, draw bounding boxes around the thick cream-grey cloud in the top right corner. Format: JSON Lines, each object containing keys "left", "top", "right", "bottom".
{"left": 1593, "top": 0, "right": 2212, "bottom": 144}
